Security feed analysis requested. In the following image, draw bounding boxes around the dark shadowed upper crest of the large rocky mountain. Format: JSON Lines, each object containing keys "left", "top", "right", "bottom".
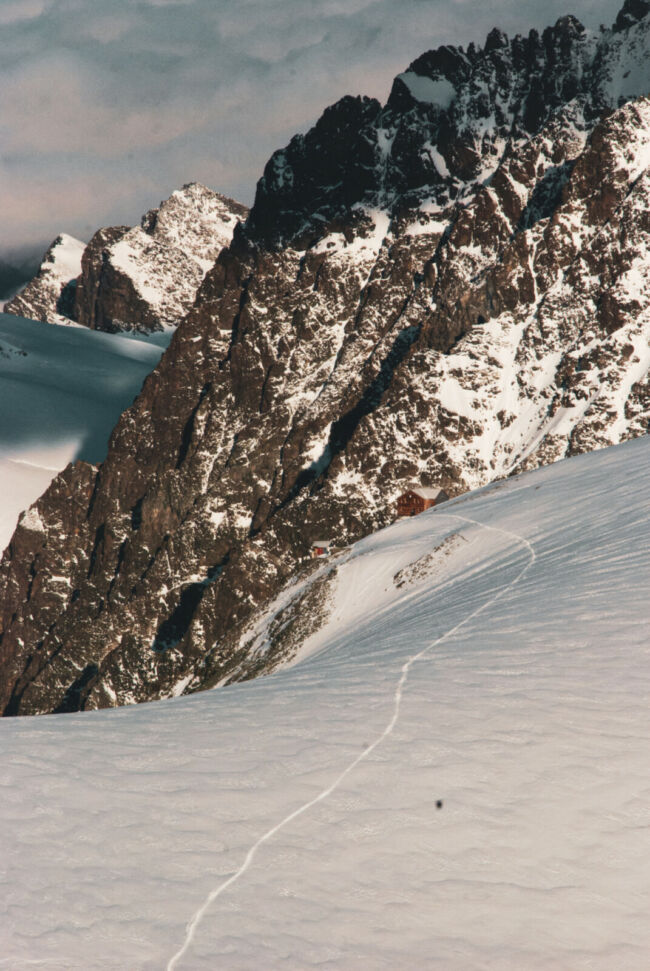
{"left": 248, "top": 7, "right": 647, "bottom": 246}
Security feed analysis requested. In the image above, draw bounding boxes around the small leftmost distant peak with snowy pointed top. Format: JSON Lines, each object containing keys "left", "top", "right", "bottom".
{"left": 5, "top": 233, "right": 85, "bottom": 324}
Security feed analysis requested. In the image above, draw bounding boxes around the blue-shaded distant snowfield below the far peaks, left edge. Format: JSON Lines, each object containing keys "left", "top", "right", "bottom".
{"left": 0, "top": 314, "right": 167, "bottom": 547}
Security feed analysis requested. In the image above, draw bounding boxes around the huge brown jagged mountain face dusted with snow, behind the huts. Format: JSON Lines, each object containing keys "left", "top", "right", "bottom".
{"left": 0, "top": 5, "right": 650, "bottom": 714}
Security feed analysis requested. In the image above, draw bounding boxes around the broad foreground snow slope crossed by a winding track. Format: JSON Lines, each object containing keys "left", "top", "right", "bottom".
{"left": 0, "top": 438, "right": 650, "bottom": 971}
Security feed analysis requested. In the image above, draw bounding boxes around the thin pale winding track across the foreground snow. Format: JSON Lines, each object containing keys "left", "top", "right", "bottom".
{"left": 166, "top": 512, "right": 537, "bottom": 971}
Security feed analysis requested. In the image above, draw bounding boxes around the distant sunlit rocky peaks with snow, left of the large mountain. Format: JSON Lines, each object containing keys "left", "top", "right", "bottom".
{"left": 6, "top": 183, "right": 248, "bottom": 332}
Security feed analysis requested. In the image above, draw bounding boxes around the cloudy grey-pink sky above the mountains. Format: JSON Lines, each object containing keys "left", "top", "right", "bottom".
{"left": 0, "top": 0, "right": 622, "bottom": 254}
